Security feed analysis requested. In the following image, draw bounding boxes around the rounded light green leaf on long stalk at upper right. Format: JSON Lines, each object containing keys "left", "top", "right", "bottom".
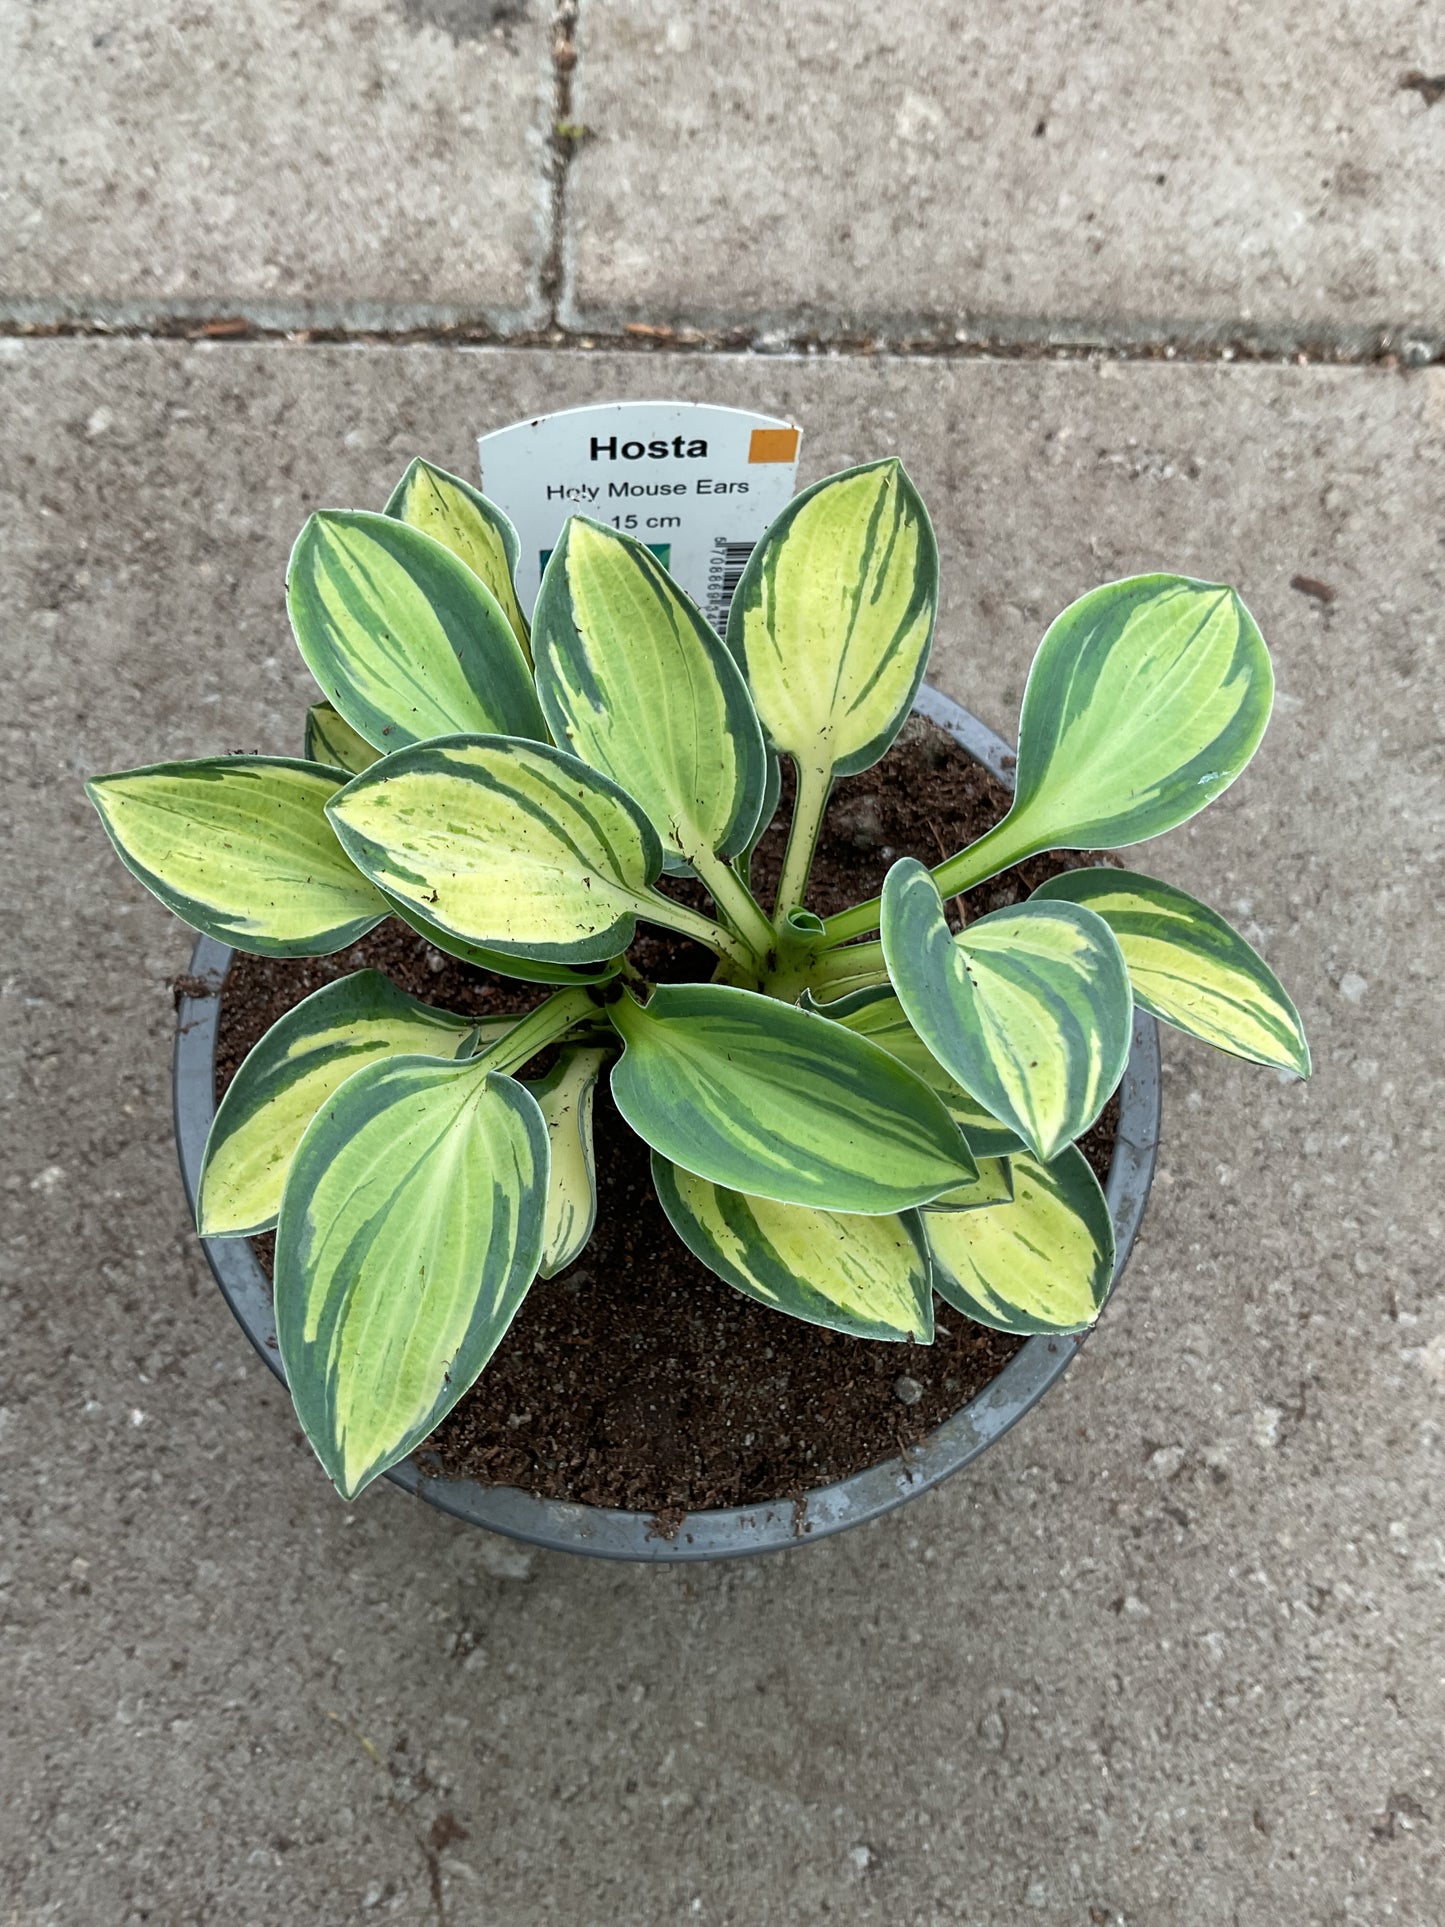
{"left": 938, "top": 576, "right": 1274, "bottom": 896}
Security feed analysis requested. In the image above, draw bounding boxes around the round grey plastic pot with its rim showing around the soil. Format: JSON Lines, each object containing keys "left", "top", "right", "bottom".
{"left": 175, "top": 686, "right": 1160, "bottom": 1561}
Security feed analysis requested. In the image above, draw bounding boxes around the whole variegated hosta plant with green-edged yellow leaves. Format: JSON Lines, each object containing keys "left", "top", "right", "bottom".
{"left": 89, "top": 461, "right": 1308, "bottom": 1549}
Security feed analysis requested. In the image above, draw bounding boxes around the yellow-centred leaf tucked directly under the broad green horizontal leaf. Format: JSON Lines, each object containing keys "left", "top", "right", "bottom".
{"left": 653, "top": 1152, "right": 933, "bottom": 1345}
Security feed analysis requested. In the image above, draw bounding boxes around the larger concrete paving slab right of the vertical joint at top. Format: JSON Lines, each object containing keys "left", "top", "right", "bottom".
{"left": 568, "top": 0, "right": 1445, "bottom": 341}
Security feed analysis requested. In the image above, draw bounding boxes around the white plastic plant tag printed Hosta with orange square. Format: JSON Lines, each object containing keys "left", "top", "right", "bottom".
{"left": 478, "top": 401, "right": 801, "bottom": 630}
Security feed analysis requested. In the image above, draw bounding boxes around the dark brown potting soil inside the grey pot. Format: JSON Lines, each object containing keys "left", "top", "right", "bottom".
{"left": 216, "top": 719, "right": 1117, "bottom": 1530}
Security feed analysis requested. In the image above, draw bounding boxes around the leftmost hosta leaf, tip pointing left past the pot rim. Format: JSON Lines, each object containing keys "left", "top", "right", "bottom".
{"left": 85, "top": 755, "right": 387, "bottom": 958}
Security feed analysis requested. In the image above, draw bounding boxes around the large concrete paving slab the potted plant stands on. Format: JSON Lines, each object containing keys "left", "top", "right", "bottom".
{"left": 0, "top": 343, "right": 1445, "bottom": 1927}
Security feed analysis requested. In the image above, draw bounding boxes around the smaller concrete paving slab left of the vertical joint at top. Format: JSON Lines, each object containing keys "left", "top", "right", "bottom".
{"left": 0, "top": 0, "right": 553, "bottom": 326}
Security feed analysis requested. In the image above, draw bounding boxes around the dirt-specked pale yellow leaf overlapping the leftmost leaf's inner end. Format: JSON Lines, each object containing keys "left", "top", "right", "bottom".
{"left": 331, "top": 736, "right": 663, "bottom": 964}
